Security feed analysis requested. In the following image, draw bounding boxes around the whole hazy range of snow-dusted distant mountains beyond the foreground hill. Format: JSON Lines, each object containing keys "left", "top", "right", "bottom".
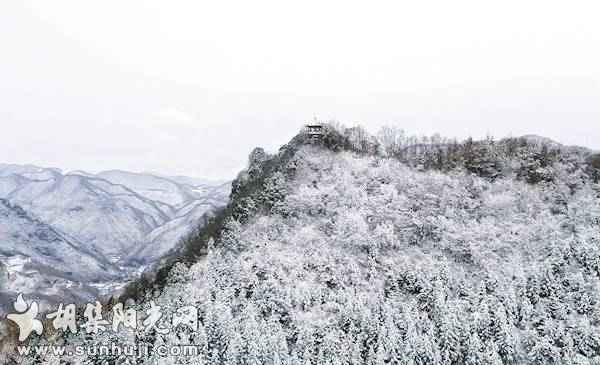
{"left": 0, "top": 164, "right": 230, "bottom": 311}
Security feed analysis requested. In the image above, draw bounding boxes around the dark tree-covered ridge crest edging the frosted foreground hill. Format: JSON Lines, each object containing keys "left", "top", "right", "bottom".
{"left": 120, "top": 123, "right": 600, "bottom": 300}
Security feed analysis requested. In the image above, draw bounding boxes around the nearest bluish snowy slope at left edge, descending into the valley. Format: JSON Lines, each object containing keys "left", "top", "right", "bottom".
{"left": 0, "top": 199, "right": 124, "bottom": 314}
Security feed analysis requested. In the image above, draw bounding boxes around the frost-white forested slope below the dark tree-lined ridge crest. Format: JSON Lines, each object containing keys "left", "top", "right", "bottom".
{"left": 136, "top": 144, "right": 600, "bottom": 364}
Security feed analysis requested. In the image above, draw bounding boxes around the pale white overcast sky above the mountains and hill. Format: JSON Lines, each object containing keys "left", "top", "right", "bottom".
{"left": 0, "top": 0, "right": 600, "bottom": 178}
